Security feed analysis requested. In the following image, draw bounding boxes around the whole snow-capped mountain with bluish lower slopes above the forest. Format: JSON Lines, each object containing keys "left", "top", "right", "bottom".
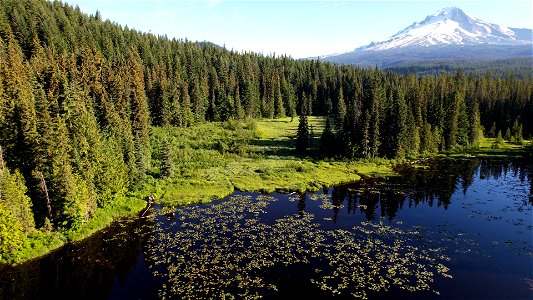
{"left": 320, "top": 7, "right": 533, "bottom": 68}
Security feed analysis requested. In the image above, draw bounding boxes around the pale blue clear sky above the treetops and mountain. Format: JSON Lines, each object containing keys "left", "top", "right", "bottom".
{"left": 64, "top": 0, "right": 533, "bottom": 58}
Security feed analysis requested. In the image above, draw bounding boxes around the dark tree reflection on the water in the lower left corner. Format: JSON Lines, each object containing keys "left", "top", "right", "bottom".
{"left": 0, "top": 214, "right": 153, "bottom": 299}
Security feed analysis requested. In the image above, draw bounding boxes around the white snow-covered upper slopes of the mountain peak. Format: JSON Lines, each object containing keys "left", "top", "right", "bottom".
{"left": 356, "top": 7, "right": 532, "bottom": 51}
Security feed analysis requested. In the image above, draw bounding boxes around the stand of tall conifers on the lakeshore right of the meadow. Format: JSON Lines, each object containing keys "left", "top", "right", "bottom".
{"left": 297, "top": 69, "right": 533, "bottom": 158}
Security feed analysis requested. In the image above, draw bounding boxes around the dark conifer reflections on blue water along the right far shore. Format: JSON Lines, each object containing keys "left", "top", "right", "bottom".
{"left": 318, "top": 159, "right": 533, "bottom": 223}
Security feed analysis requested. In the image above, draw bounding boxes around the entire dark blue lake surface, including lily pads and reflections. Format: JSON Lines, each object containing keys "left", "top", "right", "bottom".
{"left": 0, "top": 159, "right": 533, "bottom": 299}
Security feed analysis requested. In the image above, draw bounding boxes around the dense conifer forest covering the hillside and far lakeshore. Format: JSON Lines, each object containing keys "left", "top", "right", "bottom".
{"left": 0, "top": 0, "right": 533, "bottom": 253}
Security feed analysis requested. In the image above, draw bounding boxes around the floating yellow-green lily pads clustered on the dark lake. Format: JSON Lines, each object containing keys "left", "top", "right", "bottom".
{"left": 146, "top": 195, "right": 451, "bottom": 299}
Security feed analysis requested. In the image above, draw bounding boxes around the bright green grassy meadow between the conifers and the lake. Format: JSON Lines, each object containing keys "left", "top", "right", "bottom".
{"left": 145, "top": 117, "right": 394, "bottom": 205}
